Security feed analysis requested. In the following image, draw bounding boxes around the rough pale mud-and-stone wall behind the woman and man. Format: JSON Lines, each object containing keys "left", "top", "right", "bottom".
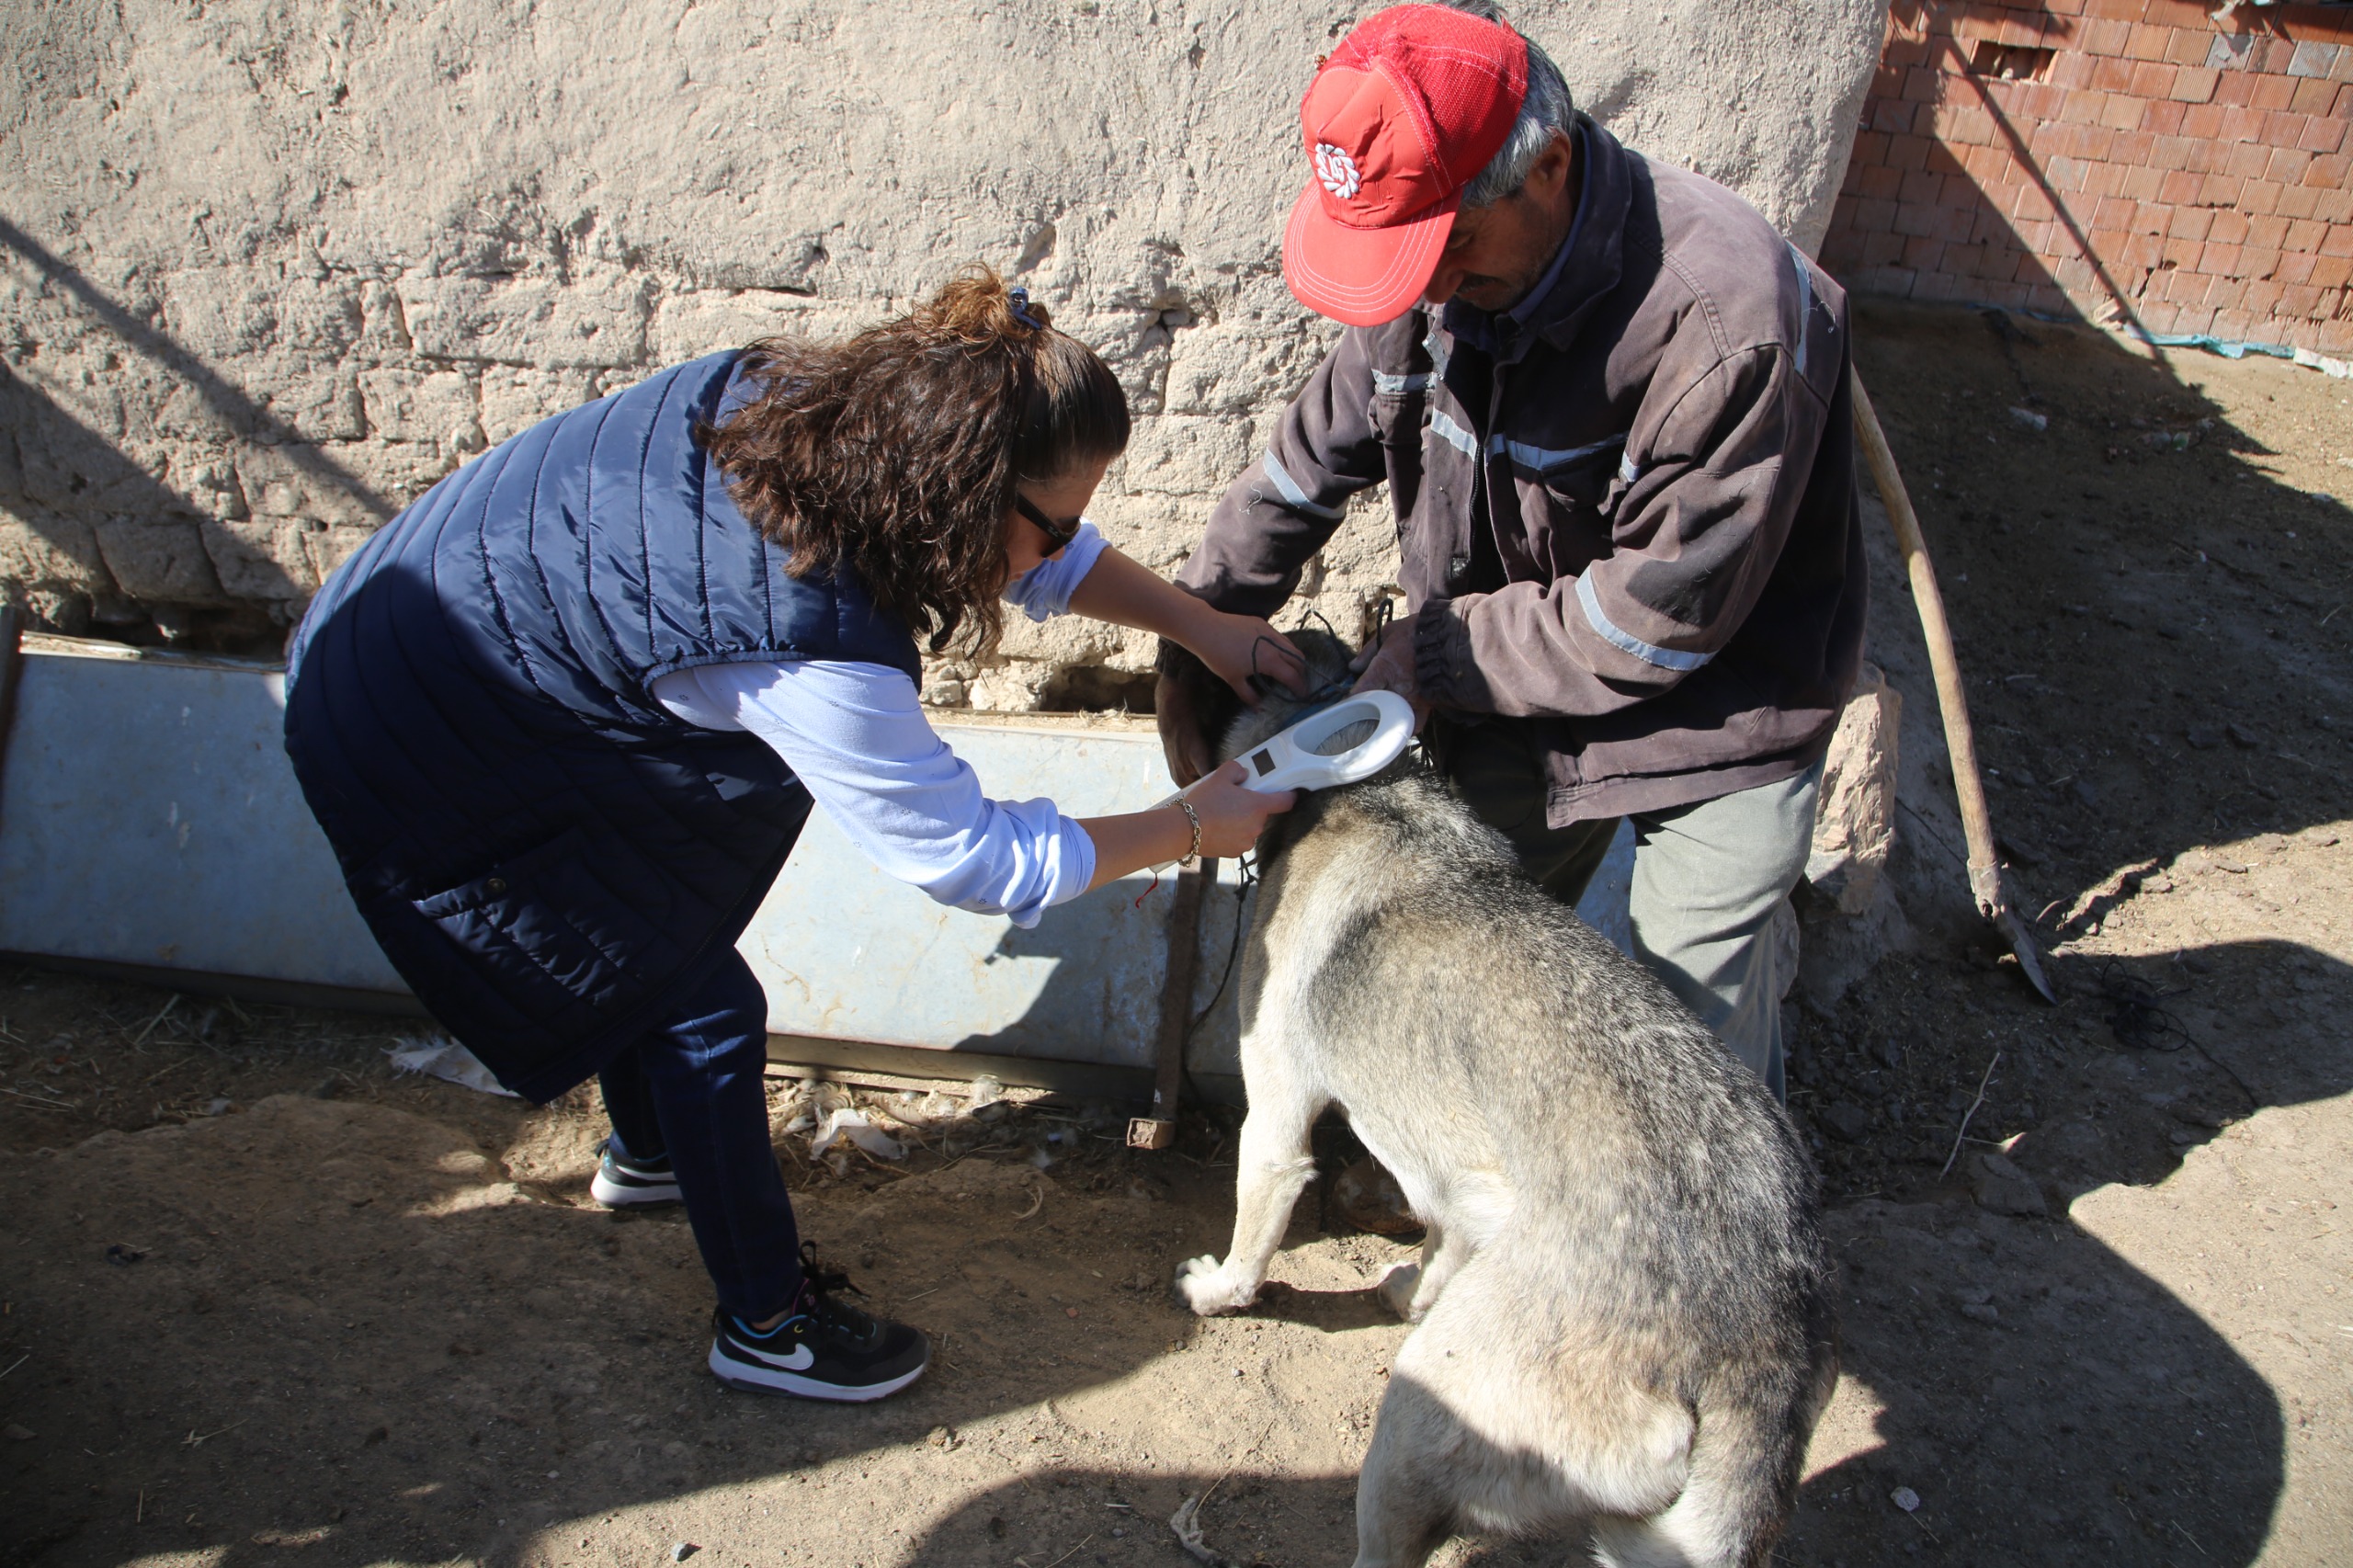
{"left": 0, "top": 0, "right": 1885, "bottom": 709}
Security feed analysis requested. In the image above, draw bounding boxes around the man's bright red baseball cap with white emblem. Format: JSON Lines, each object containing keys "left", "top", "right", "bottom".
{"left": 1282, "top": 5, "right": 1527, "bottom": 327}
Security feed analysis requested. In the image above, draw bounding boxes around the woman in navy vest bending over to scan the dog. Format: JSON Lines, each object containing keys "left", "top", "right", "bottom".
{"left": 287, "top": 271, "right": 1294, "bottom": 1401}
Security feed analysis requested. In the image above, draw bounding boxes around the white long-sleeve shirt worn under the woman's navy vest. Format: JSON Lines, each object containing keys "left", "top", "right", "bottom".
{"left": 654, "top": 523, "right": 1104, "bottom": 927}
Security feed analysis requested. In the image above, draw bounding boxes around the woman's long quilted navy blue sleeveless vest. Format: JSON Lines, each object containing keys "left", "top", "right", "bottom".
{"left": 287, "top": 353, "right": 920, "bottom": 1099}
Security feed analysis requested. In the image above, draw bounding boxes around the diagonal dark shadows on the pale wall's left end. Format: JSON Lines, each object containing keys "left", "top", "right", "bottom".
{"left": 0, "top": 219, "right": 393, "bottom": 653}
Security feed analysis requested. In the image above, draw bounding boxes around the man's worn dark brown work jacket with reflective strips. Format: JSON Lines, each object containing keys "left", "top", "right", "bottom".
{"left": 1179, "top": 120, "right": 1866, "bottom": 826}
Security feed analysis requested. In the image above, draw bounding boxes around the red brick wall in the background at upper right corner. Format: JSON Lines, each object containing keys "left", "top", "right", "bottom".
{"left": 1821, "top": 0, "right": 2353, "bottom": 356}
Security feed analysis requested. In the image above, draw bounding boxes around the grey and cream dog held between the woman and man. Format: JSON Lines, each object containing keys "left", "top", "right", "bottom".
{"left": 1176, "top": 638, "right": 1837, "bottom": 1568}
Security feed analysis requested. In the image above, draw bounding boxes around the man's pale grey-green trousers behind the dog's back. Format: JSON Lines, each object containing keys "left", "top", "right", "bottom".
{"left": 1433, "top": 722, "right": 1821, "bottom": 1099}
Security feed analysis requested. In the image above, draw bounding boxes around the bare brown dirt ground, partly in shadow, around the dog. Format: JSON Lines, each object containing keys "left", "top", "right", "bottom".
{"left": 0, "top": 309, "right": 2353, "bottom": 1568}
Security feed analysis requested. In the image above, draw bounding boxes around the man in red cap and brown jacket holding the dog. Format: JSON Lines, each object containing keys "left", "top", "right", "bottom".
{"left": 1158, "top": 0, "right": 1864, "bottom": 1095}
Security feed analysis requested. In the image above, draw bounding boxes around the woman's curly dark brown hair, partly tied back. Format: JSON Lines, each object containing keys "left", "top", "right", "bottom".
{"left": 703, "top": 266, "right": 1127, "bottom": 653}
